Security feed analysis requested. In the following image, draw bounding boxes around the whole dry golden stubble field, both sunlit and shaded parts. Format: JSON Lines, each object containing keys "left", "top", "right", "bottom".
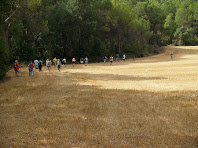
{"left": 0, "top": 46, "right": 198, "bottom": 148}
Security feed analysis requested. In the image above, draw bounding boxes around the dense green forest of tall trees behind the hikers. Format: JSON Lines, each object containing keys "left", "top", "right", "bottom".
{"left": 0, "top": 0, "right": 198, "bottom": 78}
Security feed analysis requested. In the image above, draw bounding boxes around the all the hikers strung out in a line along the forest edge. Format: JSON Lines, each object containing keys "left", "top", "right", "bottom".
{"left": 14, "top": 51, "right": 174, "bottom": 77}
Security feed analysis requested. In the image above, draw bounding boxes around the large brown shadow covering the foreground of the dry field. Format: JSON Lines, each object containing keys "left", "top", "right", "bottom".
{"left": 0, "top": 71, "right": 198, "bottom": 148}
